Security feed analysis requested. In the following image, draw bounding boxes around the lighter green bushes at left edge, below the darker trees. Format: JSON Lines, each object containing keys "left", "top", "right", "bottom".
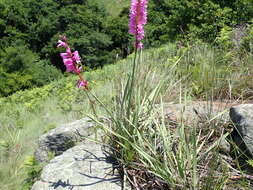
{"left": 0, "top": 45, "right": 61, "bottom": 96}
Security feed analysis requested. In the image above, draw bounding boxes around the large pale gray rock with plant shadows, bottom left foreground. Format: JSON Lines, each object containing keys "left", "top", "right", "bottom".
{"left": 31, "top": 141, "right": 121, "bottom": 190}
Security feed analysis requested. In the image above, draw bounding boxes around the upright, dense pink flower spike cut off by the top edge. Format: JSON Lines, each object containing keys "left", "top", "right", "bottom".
{"left": 129, "top": 0, "right": 148, "bottom": 48}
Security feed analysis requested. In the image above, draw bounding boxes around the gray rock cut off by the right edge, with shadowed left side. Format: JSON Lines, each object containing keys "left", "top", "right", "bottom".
{"left": 229, "top": 104, "right": 253, "bottom": 155}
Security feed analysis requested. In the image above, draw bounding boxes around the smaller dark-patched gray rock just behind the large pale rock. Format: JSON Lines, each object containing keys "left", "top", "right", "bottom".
{"left": 34, "top": 118, "right": 95, "bottom": 162}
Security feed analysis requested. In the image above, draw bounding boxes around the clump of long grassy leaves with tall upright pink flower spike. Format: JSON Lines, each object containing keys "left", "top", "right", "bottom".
{"left": 89, "top": 0, "right": 231, "bottom": 190}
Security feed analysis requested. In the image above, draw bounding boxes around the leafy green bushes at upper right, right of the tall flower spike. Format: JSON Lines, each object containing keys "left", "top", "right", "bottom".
{"left": 145, "top": 0, "right": 253, "bottom": 46}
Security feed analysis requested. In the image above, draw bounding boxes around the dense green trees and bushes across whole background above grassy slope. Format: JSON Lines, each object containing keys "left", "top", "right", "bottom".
{"left": 0, "top": 0, "right": 253, "bottom": 96}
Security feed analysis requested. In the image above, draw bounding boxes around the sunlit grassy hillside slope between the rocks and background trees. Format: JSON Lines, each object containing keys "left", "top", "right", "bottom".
{"left": 0, "top": 41, "right": 253, "bottom": 190}
